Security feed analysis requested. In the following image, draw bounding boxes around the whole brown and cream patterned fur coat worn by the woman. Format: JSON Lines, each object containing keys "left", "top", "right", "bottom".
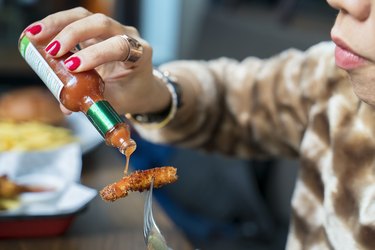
{"left": 135, "top": 42, "right": 375, "bottom": 250}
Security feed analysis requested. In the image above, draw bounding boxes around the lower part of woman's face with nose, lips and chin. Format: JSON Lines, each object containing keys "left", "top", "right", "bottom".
{"left": 327, "top": 0, "right": 375, "bottom": 106}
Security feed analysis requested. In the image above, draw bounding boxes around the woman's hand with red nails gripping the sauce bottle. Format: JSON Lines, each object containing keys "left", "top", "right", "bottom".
{"left": 25, "top": 7, "right": 170, "bottom": 113}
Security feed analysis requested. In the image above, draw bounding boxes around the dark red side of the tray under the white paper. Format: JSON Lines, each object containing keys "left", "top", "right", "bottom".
{"left": 0, "top": 207, "right": 86, "bottom": 239}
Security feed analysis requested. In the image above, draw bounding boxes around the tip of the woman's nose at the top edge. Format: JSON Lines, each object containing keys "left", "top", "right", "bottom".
{"left": 327, "top": 0, "right": 371, "bottom": 21}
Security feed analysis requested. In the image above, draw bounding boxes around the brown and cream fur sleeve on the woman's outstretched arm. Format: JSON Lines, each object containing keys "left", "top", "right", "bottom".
{"left": 136, "top": 43, "right": 348, "bottom": 157}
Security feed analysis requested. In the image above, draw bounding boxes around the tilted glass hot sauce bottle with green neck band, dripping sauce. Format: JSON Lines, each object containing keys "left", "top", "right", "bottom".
{"left": 18, "top": 34, "right": 136, "bottom": 166}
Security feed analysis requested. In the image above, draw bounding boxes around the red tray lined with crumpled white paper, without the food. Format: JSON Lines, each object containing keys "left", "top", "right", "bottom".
{"left": 0, "top": 142, "right": 97, "bottom": 238}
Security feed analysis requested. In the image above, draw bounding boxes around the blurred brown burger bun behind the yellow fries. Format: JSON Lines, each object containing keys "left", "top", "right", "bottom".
{"left": 0, "top": 87, "right": 64, "bottom": 125}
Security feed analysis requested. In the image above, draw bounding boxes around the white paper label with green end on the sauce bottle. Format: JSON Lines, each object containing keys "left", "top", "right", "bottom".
{"left": 19, "top": 36, "right": 64, "bottom": 101}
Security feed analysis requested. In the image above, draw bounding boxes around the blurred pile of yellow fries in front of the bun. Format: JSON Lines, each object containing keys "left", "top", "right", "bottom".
{"left": 0, "top": 121, "right": 76, "bottom": 152}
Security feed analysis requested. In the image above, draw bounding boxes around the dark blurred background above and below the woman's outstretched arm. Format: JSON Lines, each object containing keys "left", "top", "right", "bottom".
{"left": 0, "top": 0, "right": 336, "bottom": 250}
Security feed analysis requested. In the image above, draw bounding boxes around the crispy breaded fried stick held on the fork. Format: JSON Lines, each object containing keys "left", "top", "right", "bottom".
{"left": 100, "top": 166, "right": 178, "bottom": 201}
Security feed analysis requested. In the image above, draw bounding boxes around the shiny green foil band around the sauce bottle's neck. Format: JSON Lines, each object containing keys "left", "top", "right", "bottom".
{"left": 86, "top": 101, "right": 123, "bottom": 137}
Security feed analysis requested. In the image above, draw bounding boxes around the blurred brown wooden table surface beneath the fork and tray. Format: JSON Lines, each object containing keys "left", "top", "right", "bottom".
{"left": 0, "top": 144, "right": 194, "bottom": 250}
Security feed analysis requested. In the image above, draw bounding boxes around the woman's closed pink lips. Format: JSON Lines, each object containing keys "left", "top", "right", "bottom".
{"left": 332, "top": 38, "right": 366, "bottom": 70}
